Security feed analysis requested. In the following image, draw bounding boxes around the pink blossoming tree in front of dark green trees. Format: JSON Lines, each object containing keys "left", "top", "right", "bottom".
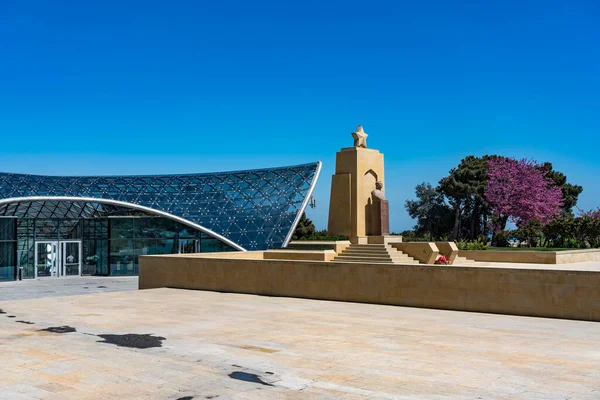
{"left": 485, "top": 158, "right": 563, "bottom": 230}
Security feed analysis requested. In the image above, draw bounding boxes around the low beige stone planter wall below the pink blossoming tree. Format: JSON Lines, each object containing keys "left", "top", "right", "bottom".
{"left": 458, "top": 249, "right": 600, "bottom": 264}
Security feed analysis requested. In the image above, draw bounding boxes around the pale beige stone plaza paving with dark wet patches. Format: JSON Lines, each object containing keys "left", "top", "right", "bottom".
{"left": 0, "top": 289, "right": 600, "bottom": 400}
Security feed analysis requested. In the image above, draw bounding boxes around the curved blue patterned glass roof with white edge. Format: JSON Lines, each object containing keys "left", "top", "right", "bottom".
{"left": 0, "top": 162, "right": 321, "bottom": 250}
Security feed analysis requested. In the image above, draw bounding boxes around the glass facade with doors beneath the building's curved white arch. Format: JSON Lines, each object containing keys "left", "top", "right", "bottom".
{"left": 0, "top": 216, "right": 235, "bottom": 281}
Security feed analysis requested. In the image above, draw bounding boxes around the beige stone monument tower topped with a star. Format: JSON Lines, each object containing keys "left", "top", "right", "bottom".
{"left": 327, "top": 125, "right": 394, "bottom": 243}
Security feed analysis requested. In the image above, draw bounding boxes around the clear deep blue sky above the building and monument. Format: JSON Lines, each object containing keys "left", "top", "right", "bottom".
{"left": 0, "top": 0, "right": 600, "bottom": 231}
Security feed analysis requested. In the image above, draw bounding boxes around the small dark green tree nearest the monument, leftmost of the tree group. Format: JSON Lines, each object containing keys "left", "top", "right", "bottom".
{"left": 404, "top": 182, "right": 453, "bottom": 240}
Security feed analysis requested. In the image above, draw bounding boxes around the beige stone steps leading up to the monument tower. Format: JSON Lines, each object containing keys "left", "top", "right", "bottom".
{"left": 333, "top": 244, "right": 419, "bottom": 264}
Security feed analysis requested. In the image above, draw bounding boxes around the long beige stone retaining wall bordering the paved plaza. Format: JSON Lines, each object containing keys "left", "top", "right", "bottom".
{"left": 139, "top": 255, "right": 600, "bottom": 321}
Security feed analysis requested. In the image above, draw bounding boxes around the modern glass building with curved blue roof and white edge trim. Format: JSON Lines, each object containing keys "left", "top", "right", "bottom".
{"left": 0, "top": 162, "right": 321, "bottom": 280}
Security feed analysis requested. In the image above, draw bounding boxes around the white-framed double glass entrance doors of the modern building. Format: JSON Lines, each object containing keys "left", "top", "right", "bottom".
{"left": 34, "top": 240, "right": 81, "bottom": 278}
